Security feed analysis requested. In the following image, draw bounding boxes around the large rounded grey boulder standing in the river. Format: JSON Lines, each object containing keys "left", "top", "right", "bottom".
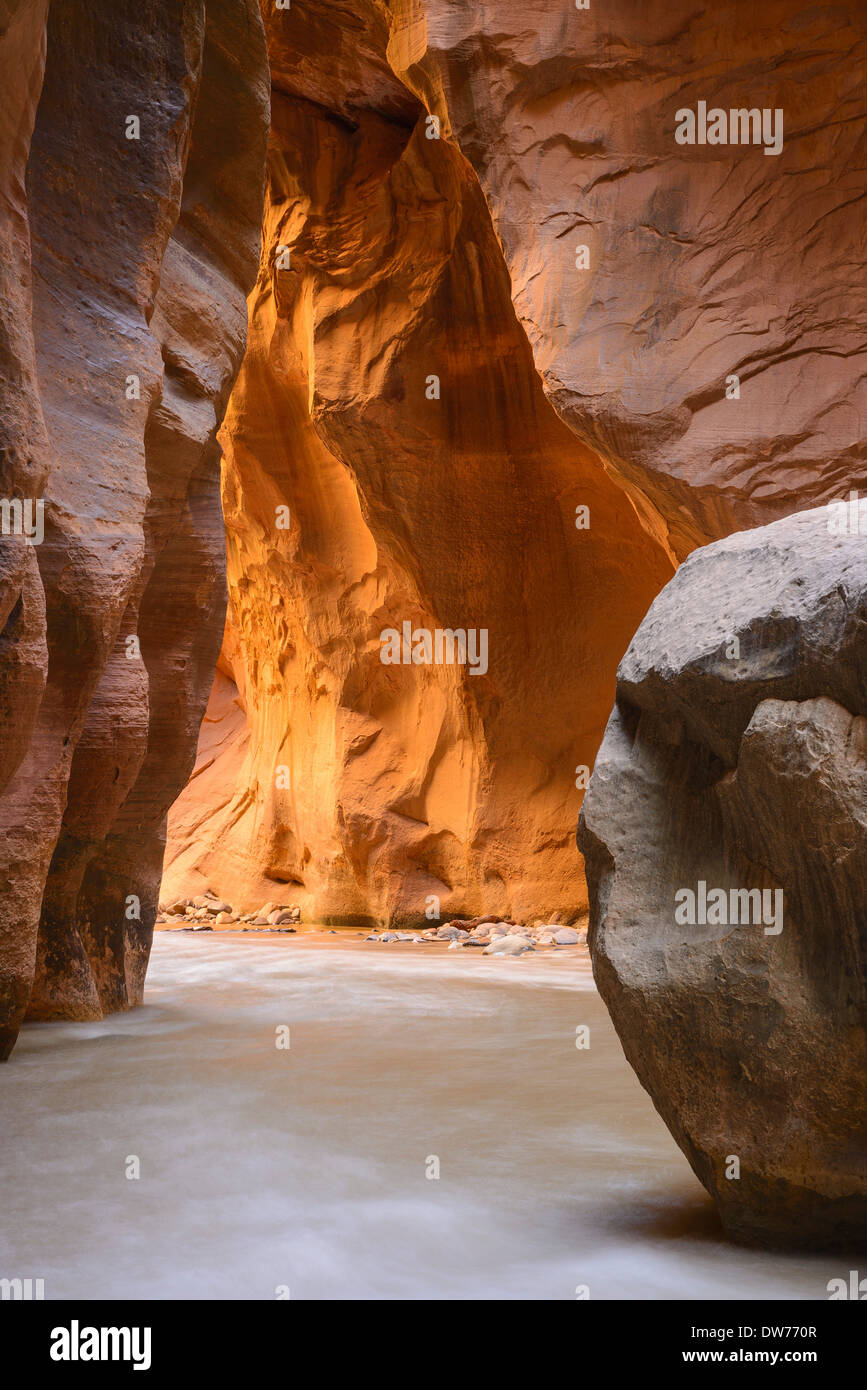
{"left": 578, "top": 507, "right": 867, "bottom": 1244}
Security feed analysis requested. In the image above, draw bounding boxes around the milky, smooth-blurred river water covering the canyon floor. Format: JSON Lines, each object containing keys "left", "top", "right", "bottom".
{"left": 0, "top": 933, "right": 848, "bottom": 1298}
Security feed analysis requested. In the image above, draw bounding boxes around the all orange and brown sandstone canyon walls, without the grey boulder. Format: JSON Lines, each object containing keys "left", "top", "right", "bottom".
{"left": 0, "top": 0, "right": 867, "bottom": 1049}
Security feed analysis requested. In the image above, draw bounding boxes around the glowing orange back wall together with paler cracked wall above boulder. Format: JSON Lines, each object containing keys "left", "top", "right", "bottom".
{"left": 164, "top": 0, "right": 867, "bottom": 923}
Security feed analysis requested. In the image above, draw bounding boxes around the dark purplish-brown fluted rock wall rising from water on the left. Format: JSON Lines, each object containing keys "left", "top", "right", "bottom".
{"left": 0, "top": 0, "right": 268, "bottom": 1052}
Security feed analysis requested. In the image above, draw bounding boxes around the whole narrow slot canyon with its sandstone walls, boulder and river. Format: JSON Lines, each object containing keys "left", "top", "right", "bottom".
{"left": 0, "top": 0, "right": 867, "bottom": 1300}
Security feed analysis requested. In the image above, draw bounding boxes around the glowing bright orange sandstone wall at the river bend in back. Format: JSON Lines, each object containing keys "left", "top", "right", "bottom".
{"left": 164, "top": 4, "right": 671, "bottom": 923}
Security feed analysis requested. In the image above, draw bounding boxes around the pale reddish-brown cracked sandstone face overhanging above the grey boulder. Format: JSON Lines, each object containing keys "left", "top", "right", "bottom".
{"left": 389, "top": 0, "right": 867, "bottom": 559}
